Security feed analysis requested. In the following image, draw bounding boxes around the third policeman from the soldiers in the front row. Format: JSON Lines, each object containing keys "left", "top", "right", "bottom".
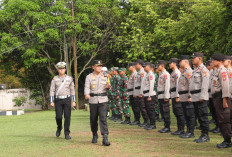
{"left": 143, "top": 62, "right": 157, "bottom": 130}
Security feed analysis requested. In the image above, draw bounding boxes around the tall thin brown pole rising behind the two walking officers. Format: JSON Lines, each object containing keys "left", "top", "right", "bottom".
{"left": 71, "top": 0, "right": 79, "bottom": 110}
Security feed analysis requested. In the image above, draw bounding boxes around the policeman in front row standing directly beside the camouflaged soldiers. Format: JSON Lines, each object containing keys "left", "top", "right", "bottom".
{"left": 127, "top": 62, "right": 140, "bottom": 125}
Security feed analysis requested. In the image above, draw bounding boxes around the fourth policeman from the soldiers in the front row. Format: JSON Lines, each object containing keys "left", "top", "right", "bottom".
{"left": 156, "top": 60, "right": 171, "bottom": 133}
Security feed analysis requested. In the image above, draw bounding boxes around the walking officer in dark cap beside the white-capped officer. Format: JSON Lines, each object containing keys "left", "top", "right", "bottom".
{"left": 84, "top": 60, "right": 110, "bottom": 146}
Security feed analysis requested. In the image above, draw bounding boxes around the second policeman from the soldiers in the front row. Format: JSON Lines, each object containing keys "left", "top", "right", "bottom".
{"left": 134, "top": 59, "right": 148, "bottom": 127}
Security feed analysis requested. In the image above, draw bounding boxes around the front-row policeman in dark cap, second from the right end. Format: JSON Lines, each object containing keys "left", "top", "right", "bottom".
{"left": 190, "top": 52, "right": 210, "bottom": 143}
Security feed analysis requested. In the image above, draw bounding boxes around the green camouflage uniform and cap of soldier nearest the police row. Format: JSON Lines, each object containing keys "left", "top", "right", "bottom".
{"left": 117, "top": 68, "right": 130, "bottom": 117}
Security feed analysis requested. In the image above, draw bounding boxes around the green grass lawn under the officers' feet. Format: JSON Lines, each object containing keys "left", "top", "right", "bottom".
{"left": 0, "top": 110, "right": 232, "bottom": 157}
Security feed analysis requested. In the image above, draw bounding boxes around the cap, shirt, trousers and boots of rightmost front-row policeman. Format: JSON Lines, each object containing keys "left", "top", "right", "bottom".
{"left": 211, "top": 53, "right": 232, "bottom": 148}
